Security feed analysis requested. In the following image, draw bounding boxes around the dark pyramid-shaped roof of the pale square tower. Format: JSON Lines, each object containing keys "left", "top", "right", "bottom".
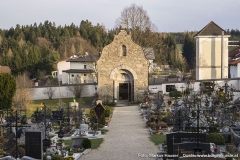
{"left": 194, "top": 21, "right": 229, "bottom": 37}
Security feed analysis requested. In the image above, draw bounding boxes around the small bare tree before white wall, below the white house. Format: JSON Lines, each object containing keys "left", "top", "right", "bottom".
{"left": 67, "top": 76, "right": 88, "bottom": 98}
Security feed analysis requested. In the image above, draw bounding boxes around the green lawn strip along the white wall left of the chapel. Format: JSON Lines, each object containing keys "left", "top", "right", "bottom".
{"left": 27, "top": 97, "right": 92, "bottom": 118}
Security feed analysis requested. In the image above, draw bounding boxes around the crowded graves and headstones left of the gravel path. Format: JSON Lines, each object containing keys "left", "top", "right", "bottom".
{"left": 0, "top": 95, "right": 111, "bottom": 159}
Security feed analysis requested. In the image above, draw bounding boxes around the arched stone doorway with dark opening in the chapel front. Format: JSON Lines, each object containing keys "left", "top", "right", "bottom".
{"left": 112, "top": 69, "right": 134, "bottom": 102}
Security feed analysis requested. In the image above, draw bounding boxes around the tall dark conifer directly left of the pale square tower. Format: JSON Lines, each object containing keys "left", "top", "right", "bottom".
{"left": 182, "top": 32, "right": 196, "bottom": 69}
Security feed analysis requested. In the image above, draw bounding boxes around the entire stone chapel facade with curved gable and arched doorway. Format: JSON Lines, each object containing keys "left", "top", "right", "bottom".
{"left": 97, "top": 30, "right": 149, "bottom": 102}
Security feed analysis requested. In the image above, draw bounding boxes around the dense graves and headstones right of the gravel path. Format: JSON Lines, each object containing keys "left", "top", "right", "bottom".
{"left": 139, "top": 81, "right": 240, "bottom": 159}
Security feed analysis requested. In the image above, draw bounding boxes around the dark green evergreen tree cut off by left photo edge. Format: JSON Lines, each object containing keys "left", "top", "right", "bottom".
{"left": 0, "top": 73, "right": 16, "bottom": 110}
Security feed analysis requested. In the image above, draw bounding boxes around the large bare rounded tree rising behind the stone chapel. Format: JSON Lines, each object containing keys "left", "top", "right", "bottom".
{"left": 116, "top": 4, "right": 156, "bottom": 48}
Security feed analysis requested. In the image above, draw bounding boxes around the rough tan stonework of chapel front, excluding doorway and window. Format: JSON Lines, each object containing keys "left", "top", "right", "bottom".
{"left": 97, "top": 30, "right": 149, "bottom": 99}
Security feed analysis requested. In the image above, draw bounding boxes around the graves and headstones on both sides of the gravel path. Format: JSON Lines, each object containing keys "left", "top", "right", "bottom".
{"left": 0, "top": 81, "right": 240, "bottom": 160}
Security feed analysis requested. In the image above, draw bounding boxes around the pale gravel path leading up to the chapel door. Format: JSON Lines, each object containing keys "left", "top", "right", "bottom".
{"left": 80, "top": 105, "right": 159, "bottom": 160}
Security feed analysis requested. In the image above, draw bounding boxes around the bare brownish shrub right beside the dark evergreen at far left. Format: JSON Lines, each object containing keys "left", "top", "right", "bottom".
{"left": 13, "top": 73, "right": 34, "bottom": 114}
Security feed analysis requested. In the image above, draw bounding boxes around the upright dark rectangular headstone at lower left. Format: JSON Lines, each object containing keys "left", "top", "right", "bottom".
{"left": 25, "top": 132, "right": 42, "bottom": 159}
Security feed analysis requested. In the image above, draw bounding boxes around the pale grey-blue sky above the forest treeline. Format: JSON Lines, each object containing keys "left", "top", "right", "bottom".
{"left": 0, "top": 0, "right": 240, "bottom": 32}
